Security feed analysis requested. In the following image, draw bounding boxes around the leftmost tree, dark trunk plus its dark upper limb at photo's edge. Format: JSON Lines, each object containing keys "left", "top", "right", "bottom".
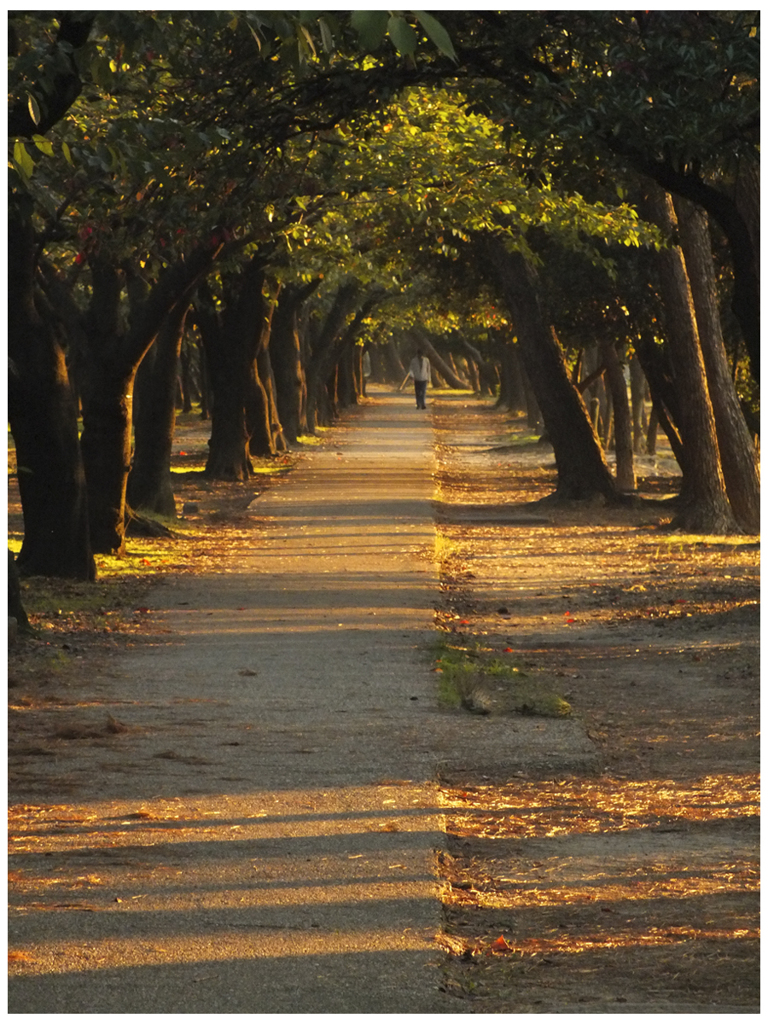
{"left": 8, "top": 13, "right": 95, "bottom": 580}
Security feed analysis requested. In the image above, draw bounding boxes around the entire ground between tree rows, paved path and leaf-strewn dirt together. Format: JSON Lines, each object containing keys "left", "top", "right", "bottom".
{"left": 9, "top": 393, "right": 758, "bottom": 1013}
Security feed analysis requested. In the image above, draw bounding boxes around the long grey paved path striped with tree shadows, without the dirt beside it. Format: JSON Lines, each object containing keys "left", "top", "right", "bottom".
{"left": 9, "top": 394, "right": 593, "bottom": 1013}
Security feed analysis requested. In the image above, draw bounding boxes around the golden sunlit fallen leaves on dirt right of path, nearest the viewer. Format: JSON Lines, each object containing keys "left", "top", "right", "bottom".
{"left": 443, "top": 772, "right": 760, "bottom": 963}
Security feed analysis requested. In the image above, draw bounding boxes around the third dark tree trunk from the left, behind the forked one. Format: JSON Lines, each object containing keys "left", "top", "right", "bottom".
{"left": 127, "top": 303, "right": 186, "bottom": 518}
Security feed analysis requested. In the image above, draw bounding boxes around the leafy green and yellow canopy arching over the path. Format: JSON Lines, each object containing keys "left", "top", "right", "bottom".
{"left": 8, "top": 11, "right": 759, "bottom": 573}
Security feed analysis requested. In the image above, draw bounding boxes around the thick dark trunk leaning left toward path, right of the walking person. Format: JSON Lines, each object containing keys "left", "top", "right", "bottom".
{"left": 480, "top": 236, "right": 616, "bottom": 500}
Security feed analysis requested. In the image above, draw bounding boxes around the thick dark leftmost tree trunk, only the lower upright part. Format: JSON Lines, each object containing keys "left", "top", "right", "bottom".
{"left": 8, "top": 197, "right": 96, "bottom": 580}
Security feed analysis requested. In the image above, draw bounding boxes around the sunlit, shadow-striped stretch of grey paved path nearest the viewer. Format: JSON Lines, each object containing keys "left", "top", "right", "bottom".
{"left": 9, "top": 780, "right": 438, "bottom": 976}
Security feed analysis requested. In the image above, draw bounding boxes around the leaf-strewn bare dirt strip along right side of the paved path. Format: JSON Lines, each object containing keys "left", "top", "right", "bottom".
{"left": 430, "top": 400, "right": 759, "bottom": 1014}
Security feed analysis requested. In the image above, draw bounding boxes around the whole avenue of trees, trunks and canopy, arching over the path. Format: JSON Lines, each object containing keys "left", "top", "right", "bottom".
{"left": 8, "top": 10, "right": 760, "bottom": 580}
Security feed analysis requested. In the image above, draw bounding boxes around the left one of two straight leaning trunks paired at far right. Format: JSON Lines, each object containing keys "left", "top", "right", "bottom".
{"left": 644, "top": 185, "right": 738, "bottom": 534}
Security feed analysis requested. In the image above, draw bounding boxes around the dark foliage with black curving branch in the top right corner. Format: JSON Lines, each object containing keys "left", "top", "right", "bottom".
{"left": 440, "top": 10, "right": 760, "bottom": 378}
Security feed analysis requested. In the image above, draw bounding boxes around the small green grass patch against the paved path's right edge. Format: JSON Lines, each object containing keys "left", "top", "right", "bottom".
{"left": 434, "top": 638, "right": 571, "bottom": 718}
